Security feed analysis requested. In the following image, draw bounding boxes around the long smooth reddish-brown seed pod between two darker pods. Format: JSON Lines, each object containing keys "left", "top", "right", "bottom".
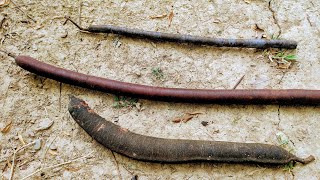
{"left": 11, "top": 56, "right": 320, "bottom": 105}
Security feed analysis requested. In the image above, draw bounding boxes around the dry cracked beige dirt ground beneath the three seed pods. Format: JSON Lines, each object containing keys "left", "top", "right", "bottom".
{"left": 0, "top": 0, "right": 320, "bottom": 180}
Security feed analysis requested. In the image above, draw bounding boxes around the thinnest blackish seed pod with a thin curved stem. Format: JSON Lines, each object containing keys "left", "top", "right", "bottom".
{"left": 66, "top": 17, "right": 297, "bottom": 49}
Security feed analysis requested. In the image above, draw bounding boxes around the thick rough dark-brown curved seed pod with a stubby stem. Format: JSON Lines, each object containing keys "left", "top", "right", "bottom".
{"left": 69, "top": 96, "right": 315, "bottom": 164}
